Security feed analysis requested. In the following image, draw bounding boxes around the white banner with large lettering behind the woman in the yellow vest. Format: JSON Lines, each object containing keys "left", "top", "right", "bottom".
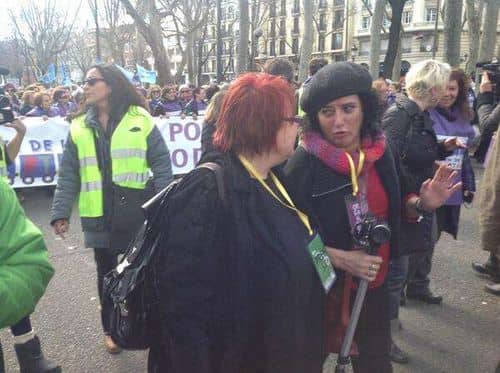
{"left": 0, "top": 116, "right": 203, "bottom": 188}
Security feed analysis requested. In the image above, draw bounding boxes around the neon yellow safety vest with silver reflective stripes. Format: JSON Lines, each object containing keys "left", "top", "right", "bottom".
{"left": 70, "top": 106, "right": 154, "bottom": 217}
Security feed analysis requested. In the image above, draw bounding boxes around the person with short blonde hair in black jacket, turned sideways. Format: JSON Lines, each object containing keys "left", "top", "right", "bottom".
{"left": 382, "top": 60, "right": 463, "bottom": 363}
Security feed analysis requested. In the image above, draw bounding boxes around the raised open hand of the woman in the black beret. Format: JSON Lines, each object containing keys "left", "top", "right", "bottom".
{"left": 419, "top": 164, "right": 462, "bottom": 211}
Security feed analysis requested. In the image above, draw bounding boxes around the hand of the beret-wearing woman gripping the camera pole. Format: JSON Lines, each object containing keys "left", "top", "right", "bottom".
{"left": 326, "top": 247, "right": 383, "bottom": 282}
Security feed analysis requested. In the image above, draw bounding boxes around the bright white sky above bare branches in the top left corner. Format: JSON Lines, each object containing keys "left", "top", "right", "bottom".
{"left": 0, "top": 0, "right": 91, "bottom": 39}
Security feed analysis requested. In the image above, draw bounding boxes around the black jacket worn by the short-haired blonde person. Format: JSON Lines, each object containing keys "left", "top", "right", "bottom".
{"left": 382, "top": 95, "right": 449, "bottom": 191}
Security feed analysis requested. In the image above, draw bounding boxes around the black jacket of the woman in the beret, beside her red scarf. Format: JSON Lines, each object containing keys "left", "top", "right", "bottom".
{"left": 284, "top": 147, "right": 402, "bottom": 257}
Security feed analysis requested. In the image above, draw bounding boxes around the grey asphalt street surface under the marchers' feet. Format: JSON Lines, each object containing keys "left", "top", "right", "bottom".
{"left": 0, "top": 166, "right": 500, "bottom": 373}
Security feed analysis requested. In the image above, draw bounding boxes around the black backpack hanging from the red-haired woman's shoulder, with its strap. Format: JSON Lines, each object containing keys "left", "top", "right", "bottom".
{"left": 102, "top": 162, "right": 227, "bottom": 350}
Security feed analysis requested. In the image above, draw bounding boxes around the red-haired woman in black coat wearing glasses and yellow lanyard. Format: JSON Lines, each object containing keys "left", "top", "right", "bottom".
{"left": 149, "top": 74, "right": 340, "bottom": 373}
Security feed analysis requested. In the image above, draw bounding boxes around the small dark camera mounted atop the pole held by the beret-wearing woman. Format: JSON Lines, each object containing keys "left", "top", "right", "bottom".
{"left": 352, "top": 214, "right": 391, "bottom": 253}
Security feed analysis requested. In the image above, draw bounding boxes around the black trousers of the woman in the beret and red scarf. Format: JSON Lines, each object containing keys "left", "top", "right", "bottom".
{"left": 351, "top": 285, "right": 392, "bottom": 373}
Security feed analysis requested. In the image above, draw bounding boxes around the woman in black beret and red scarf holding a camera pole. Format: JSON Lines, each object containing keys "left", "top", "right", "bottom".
{"left": 284, "top": 62, "right": 457, "bottom": 373}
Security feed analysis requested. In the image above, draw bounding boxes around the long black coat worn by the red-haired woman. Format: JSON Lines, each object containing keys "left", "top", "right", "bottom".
{"left": 150, "top": 153, "right": 325, "bottom": 373}
